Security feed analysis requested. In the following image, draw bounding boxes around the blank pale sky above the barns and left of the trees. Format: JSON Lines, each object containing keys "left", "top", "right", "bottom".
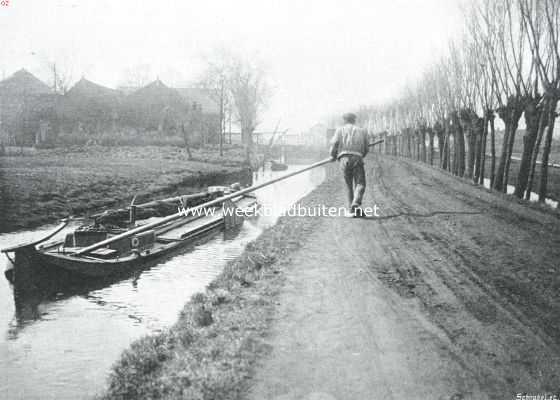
{"left": 0, "top": 0, "right": 462, "bottom": 132}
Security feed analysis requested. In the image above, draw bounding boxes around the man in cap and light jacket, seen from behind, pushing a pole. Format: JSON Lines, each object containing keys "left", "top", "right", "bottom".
{"left": 331, "top": 113, "right": 369, "bottom": 217}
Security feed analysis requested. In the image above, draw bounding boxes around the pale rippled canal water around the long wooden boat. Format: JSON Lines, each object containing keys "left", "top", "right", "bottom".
{"left": 0, "top": 166, "right": 325, "bottom": 400}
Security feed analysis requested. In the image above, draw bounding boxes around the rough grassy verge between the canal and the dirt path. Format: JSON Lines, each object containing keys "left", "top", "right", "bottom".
{"left": 100, "top": 186, "right": 327, "bottom": 400}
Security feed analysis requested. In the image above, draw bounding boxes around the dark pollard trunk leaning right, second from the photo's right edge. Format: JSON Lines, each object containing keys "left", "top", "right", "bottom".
{"left": 514, "top": 98, "right": 542, "bottom": 199}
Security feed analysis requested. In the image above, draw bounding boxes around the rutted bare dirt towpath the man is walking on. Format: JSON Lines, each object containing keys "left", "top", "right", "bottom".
{"left": 247, "top": 155, "right": 560, "bottom": 400}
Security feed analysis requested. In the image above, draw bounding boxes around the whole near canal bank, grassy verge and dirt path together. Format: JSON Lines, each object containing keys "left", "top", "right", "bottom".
{"left": 103, "top": 155, "right": 560, "bottom": 400}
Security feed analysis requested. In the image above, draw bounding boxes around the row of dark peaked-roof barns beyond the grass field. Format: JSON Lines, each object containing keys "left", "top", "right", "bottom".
{"left": 0, "top": 69, "right": 225, "bottom": 145}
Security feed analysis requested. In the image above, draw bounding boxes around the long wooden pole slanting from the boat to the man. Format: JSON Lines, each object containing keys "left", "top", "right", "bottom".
{"left": 74, "top": 140, "right": 383, "bottom": 256}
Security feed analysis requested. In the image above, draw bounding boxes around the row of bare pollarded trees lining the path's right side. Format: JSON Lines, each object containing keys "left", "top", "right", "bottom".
{"left": 359, "top": 0, "right": 560, "bottom": 201}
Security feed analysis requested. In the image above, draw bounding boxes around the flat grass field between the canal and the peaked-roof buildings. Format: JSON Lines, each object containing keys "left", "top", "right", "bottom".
{"left": 0, "top": 146, "right": 249, "bottom": 232}
